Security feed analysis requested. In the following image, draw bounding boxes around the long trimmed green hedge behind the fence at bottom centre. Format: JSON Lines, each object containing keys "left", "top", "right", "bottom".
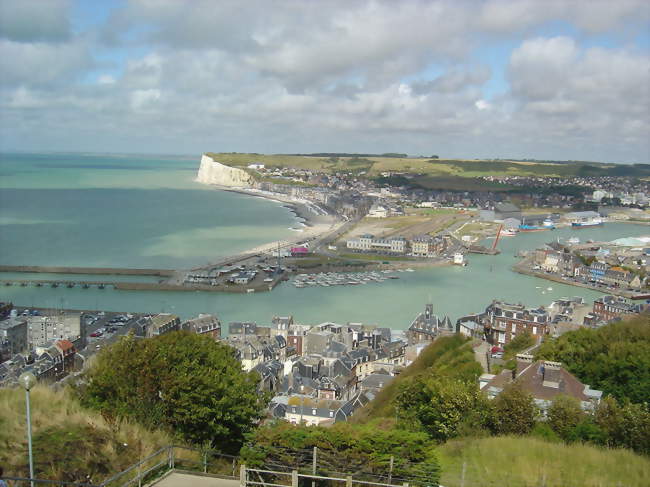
{"left": 241, "top": 422, "right": 439, "bottom": 486}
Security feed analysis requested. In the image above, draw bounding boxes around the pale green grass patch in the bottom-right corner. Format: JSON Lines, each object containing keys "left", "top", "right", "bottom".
{"left": 438, "top": 436, "right": 650, "bottom": 487}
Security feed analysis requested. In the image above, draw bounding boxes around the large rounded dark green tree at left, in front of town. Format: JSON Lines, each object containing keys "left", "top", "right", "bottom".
{"left": 79, "top": 332, "right": 265, "bottom": 450}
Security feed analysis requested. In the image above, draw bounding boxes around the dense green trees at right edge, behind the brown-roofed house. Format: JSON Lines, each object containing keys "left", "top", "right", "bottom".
{"left": 538, "top": 314, "right": 650, "bottom": 403}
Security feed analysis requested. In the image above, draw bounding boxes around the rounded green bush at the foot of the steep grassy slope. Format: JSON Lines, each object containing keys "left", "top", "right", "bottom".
{"left": 395, "top": 375, "right": 490, "bottom": 441}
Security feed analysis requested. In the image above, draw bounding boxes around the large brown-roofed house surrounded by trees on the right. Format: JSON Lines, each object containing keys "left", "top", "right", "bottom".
{"left": 481, "top": 354, "right": 603, "bottom": 413}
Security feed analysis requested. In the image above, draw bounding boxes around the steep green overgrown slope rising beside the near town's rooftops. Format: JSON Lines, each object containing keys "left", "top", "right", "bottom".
{"left": 353, "top": 334, "right": 483, "bottom": 422}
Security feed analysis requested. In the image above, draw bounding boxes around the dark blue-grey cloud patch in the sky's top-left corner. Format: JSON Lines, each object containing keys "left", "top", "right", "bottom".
{"left": 0, "top": 0, "right": 71, "bottom": 42}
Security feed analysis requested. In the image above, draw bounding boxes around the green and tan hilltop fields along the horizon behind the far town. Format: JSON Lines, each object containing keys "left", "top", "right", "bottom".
{"left": 207, "top": 152, "right": 650, "bottom": 180}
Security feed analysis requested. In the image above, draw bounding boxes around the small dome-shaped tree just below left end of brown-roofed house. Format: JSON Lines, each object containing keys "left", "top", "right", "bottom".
{"left": 492, "top": 382, "right": 537, "bottom": 435}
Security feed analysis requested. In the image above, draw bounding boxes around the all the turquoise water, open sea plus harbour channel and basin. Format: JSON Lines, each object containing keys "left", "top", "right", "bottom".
{"left": 0, "top": 153, "right": 650, "bottom": 329}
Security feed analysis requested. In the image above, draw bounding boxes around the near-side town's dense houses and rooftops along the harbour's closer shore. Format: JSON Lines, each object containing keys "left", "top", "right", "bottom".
{"left": 0, "top": 284, "right": 650, "bottom": 425}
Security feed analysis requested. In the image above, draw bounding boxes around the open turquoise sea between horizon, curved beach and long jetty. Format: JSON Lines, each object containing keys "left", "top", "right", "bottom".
{"left": 0, "top": 154, "right": 295, "bottom": 269}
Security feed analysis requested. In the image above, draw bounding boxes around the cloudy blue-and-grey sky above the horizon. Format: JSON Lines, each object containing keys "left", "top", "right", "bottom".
{"left": 0, "top": 0, "right": 650, "bottom": 163}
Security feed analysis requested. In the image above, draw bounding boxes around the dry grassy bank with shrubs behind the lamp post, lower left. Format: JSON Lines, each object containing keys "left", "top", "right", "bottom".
{"left": 0, "top": 386, "right": 197, "bottom": 483}
